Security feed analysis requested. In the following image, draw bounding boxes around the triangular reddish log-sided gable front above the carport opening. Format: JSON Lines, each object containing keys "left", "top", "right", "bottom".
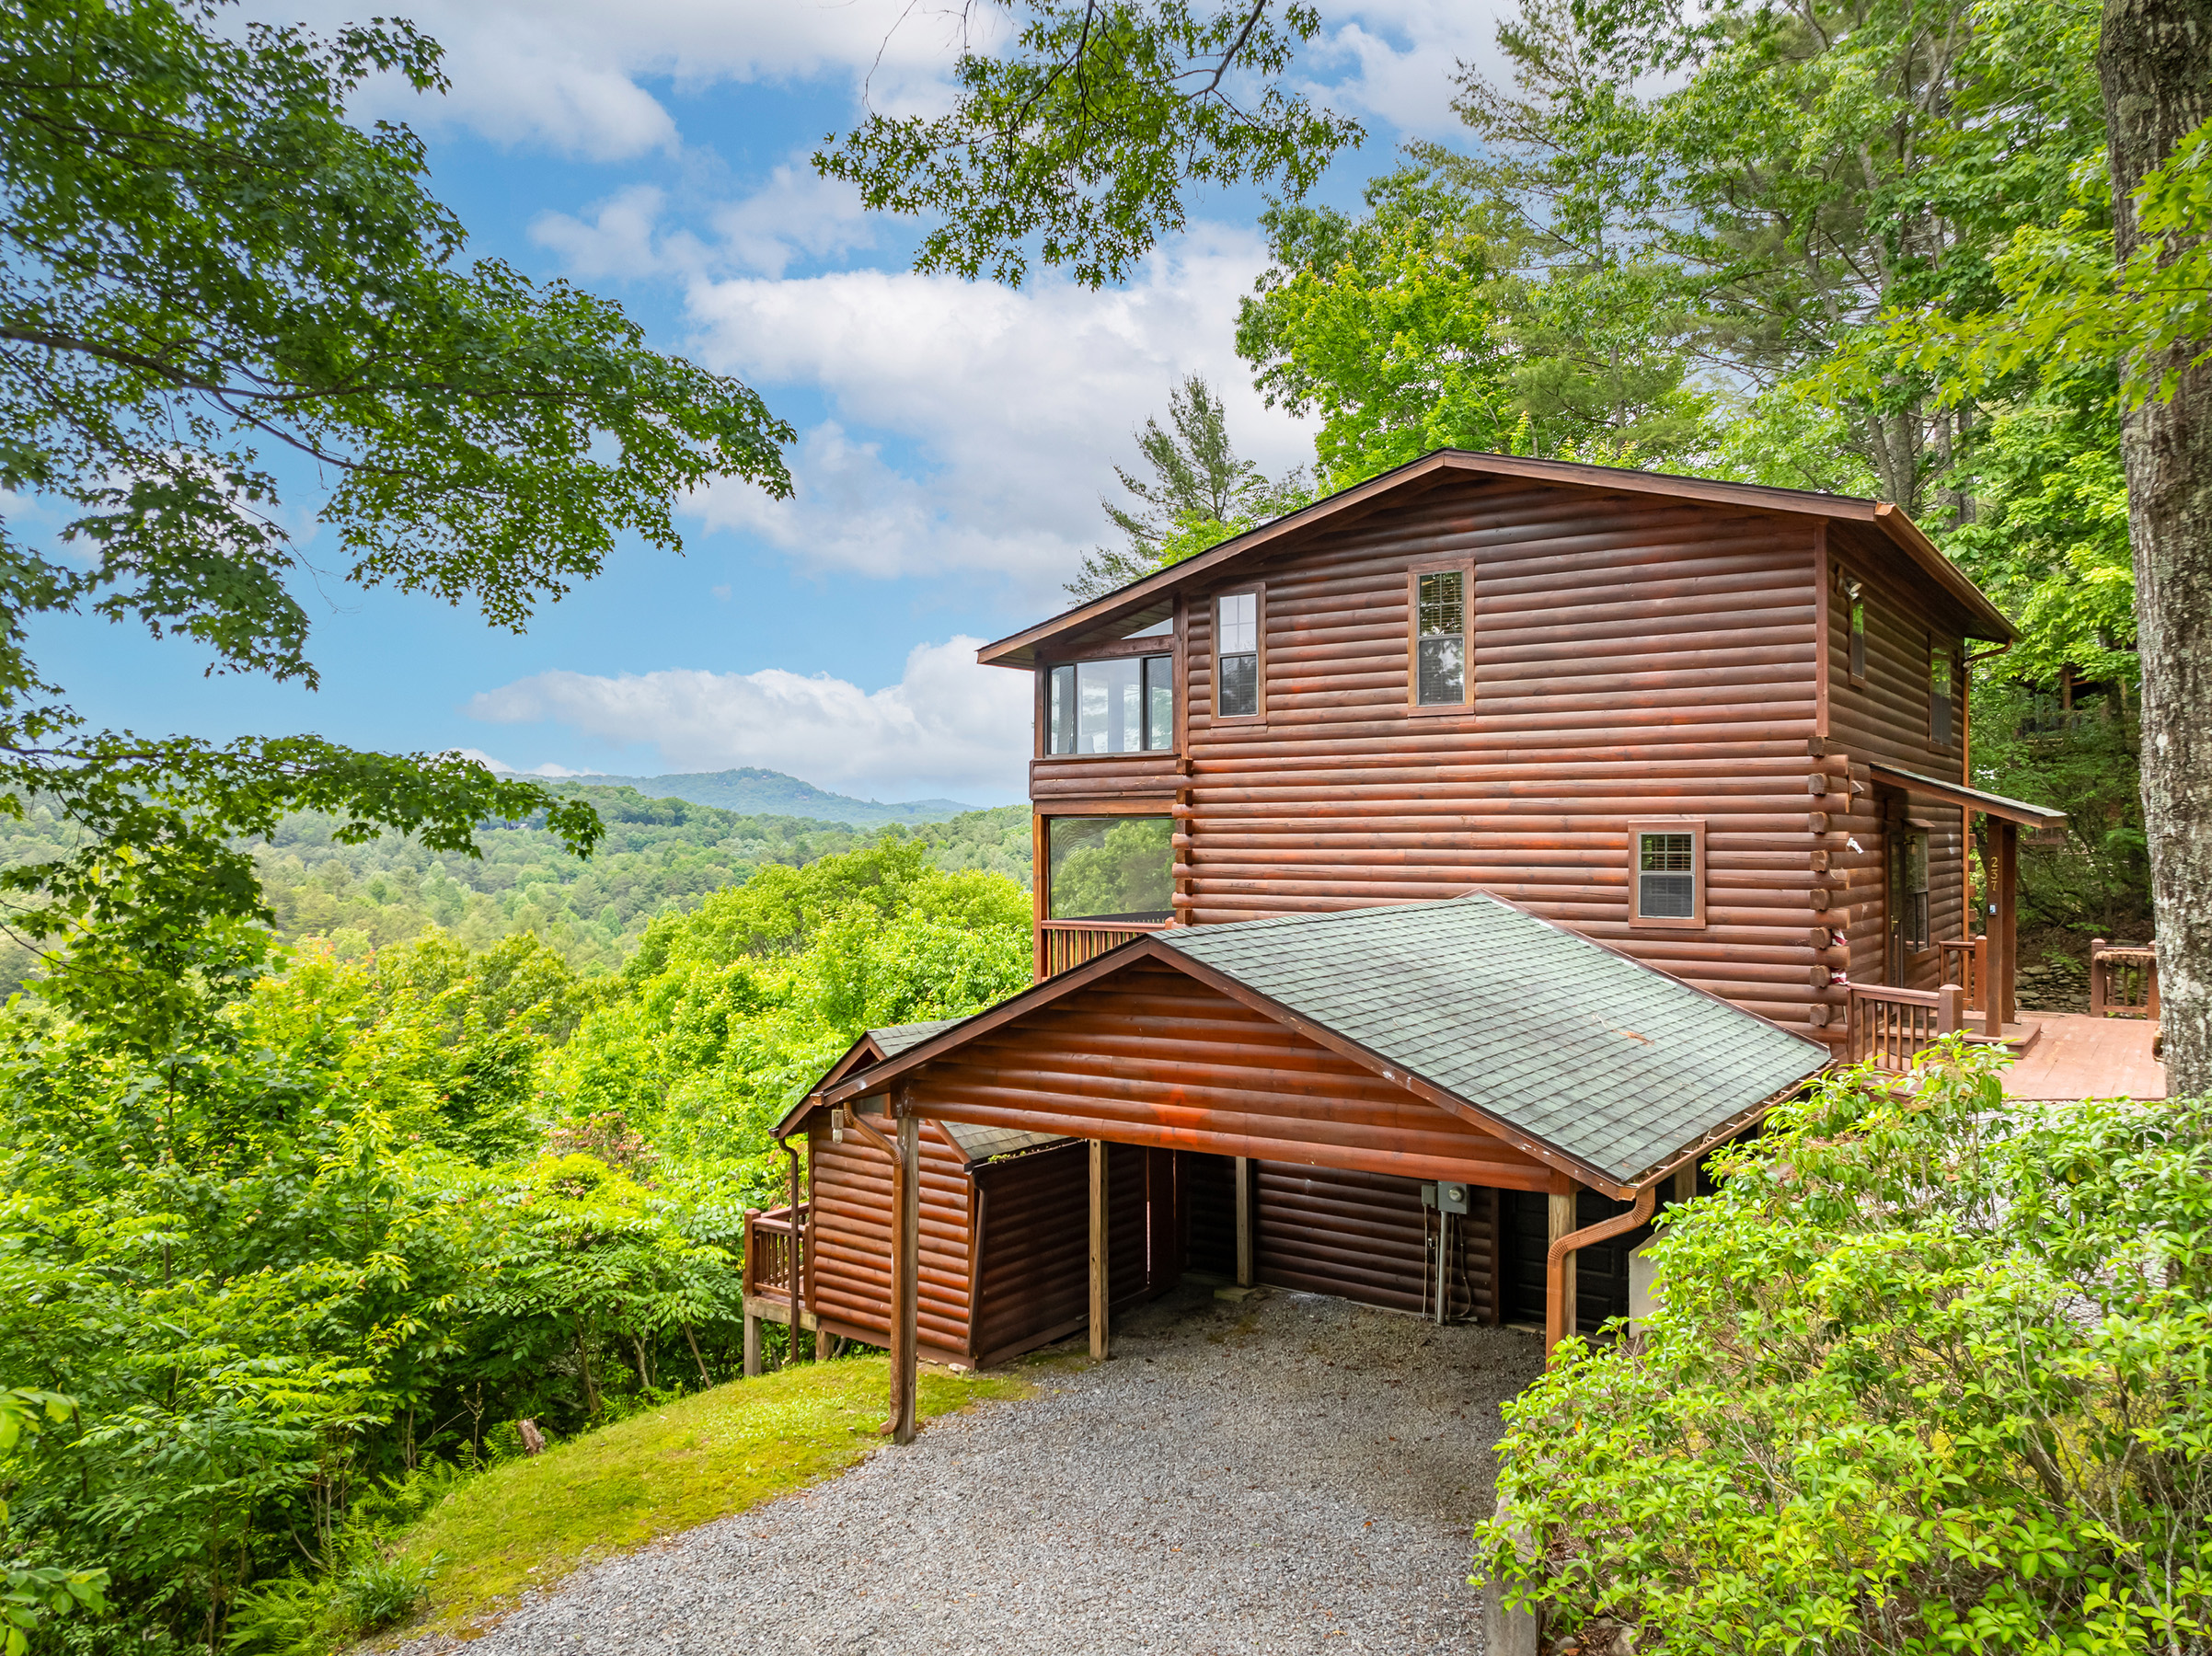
{"left": 911, "top": 964, "right": 1550, "bottom": 1194}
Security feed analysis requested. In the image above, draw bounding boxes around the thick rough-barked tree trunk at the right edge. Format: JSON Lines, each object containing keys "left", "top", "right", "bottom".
{"left": 2097, "top": 0, "right": 2212, "bottom": 1097}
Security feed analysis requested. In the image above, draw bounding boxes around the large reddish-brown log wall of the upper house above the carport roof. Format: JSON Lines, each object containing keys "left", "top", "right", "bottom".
{"left": 1176, "top": 468, "right": 1825, "bottom": 1028}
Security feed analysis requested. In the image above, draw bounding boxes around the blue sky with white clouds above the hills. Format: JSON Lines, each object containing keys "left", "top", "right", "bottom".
{"left": 60, "top": 0, "right": 1495, "bottom": 802}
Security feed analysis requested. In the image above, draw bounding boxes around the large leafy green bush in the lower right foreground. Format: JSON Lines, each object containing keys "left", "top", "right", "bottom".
{"left": 1475, "top": 1043, "right": 2212, "bottom": 1656}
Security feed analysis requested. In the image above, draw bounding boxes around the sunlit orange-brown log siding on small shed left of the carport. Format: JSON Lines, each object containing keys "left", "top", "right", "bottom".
{"left": 807, "top": 1110, "right": 974, "bottom": 1362}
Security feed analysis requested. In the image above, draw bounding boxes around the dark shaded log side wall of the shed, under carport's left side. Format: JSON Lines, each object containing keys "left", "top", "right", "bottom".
{"left": 975, "top": 1143, "right": 1090, "bottom": 1362}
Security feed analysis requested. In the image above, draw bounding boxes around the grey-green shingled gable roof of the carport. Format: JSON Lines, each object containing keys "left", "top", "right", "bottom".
{"left": 816, "top": 893, "right": 1829, "bottom": 1191}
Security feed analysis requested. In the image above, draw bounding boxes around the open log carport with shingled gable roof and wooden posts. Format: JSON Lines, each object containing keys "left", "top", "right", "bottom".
{"left": 807, "top": 895, "right": 1829, "bottom": 1439}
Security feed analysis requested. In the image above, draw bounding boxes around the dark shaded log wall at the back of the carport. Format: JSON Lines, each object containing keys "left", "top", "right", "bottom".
{"left": 1256, "top": 1163, "right": 1498, "bottom": 1322}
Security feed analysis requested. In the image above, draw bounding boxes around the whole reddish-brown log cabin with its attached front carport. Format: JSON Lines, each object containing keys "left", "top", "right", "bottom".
{"left": 752, "top": 451, "right": 2062, "bottom": 1413}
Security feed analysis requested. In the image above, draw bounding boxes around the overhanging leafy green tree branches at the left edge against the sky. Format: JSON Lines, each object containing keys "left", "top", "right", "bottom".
{"left": 0, "top": 0, "right": 789, "bottom": 1046}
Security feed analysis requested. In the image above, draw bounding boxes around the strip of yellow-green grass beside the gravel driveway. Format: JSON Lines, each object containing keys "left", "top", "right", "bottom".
{"left": 386, "top": 1358, "right": 1031, "bottom": 1634}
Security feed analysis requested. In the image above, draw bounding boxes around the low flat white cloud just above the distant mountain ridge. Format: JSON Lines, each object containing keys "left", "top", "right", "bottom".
{"left": 469, "top": 637, "right": 1031, "bottom": 799}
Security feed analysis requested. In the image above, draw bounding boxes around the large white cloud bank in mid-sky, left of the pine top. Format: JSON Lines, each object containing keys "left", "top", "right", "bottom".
{"left": 690, "top": 225, "right": 1312, "bottom": 604}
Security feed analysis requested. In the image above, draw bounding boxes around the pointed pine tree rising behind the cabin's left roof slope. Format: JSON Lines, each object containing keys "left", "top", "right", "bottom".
{"left": 1066, "top": 374, "right": 1312, "bottom": 599}
